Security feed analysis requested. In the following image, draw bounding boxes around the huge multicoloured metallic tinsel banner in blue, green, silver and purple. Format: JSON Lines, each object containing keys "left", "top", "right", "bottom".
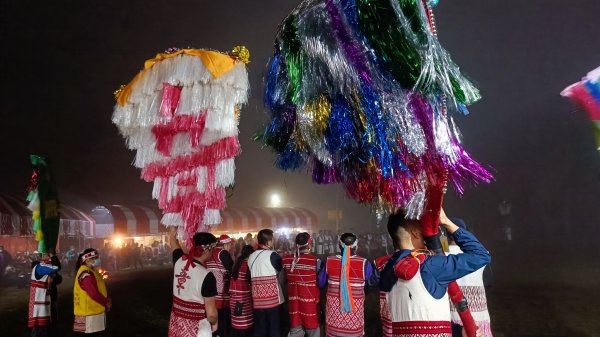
{"left": 259, "top": 0, "right": 492, "bottom": 218}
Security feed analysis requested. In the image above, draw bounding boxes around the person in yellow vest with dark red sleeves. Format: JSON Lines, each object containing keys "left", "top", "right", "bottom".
{"left": 73, "top": 248, "right": 112, "bottom": 334}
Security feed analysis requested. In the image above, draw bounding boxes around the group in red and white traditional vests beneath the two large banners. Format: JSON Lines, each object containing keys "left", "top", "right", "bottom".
{"left": 169, "top": 207, "right": 492, "bottom": 337}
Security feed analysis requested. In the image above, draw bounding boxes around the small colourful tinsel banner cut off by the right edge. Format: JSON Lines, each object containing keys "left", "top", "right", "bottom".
{"left": 560, "top": 67, "right": 600, "bottom": 151}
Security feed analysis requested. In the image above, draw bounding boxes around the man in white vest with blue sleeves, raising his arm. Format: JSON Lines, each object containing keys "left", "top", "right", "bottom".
{"left": 379, "top": 210, "right": 491, "bottom": 336}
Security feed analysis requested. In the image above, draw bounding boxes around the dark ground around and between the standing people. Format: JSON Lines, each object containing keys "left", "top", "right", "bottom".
{"left": 0, "top": 261, "right": 600, "bottom": 337}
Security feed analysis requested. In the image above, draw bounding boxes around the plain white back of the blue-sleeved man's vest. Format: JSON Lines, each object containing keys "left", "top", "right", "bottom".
{"left": 387, "top": 264, "right": 450, "bottom": 322}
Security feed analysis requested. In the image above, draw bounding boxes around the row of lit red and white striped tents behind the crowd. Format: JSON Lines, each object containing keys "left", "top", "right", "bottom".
{"left": 0, "top": 194, "right": 317, "bottom": 252}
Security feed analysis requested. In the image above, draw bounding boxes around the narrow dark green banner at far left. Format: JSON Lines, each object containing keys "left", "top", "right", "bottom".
{"left": 27, "top": 154, "right": 60, "bottom": 253}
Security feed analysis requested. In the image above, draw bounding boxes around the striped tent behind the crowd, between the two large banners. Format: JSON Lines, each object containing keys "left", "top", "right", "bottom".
{"left": 212, "top": 207, "right": 318, "bottom": 235}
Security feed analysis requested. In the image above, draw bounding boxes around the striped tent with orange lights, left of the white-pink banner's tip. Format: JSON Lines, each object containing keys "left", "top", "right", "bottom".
{"left": 91, "top": 205, "right": 166, "bottom": 238}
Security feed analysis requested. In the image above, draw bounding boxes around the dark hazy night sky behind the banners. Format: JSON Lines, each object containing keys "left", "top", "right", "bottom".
{"left": 0, "top": 0, "right": 600, "bottom": 244}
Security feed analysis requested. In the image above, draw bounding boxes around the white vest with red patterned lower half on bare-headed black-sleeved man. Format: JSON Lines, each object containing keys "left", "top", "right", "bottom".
{"left": 248, "top": 249, "right": 284, "bottom": 309}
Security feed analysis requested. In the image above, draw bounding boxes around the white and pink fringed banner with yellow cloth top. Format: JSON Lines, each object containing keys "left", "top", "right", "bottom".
{"left": 112, "top": 47, "right": 249, "bottom": 245}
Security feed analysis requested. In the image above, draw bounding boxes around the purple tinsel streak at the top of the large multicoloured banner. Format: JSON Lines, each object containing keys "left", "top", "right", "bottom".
{"left": 325, "top": 0, "right": 371, "bottom": 84}
